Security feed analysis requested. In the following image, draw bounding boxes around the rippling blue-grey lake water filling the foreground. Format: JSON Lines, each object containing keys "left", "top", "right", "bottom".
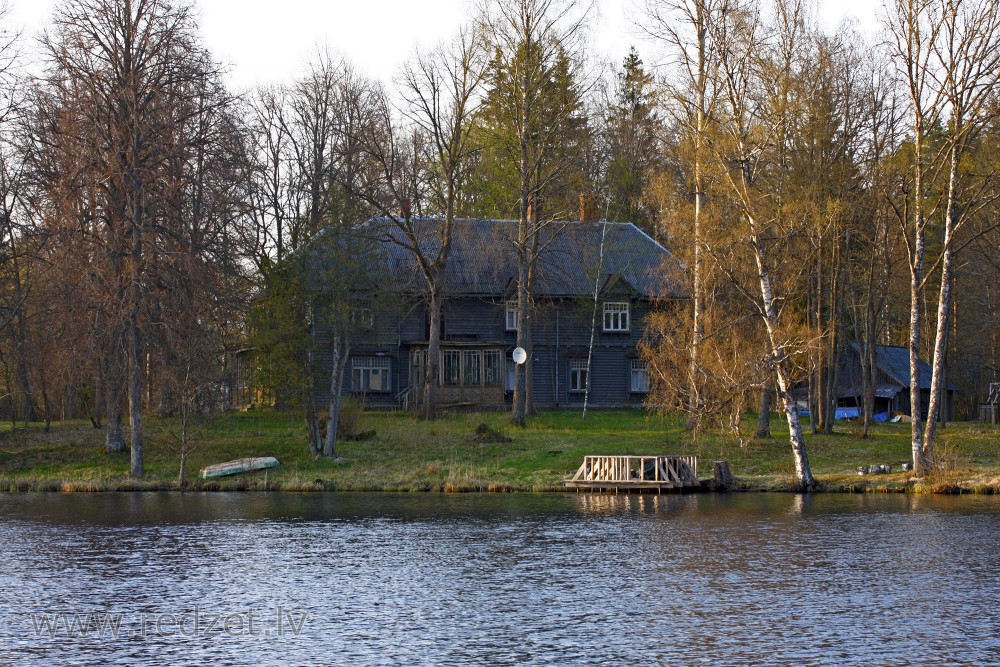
{"left": 0, "top": 494, "right": 1000, "bottom": 667}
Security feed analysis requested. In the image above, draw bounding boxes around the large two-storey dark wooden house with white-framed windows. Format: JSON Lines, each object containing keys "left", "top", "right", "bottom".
{"left": 315, "top": 219, "right": 684, "bottom": 408}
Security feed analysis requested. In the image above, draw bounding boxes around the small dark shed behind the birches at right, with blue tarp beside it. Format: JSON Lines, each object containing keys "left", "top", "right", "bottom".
{"left": 837, "top": 342, "right": 958, "bottom": 421}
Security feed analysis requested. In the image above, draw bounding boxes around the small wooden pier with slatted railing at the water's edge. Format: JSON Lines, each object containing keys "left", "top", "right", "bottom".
{"left": 566, "top": 456, "right": 699, "bottom": 492}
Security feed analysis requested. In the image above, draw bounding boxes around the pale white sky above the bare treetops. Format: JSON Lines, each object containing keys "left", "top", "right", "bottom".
{"left": 7, "top": 0, "right": 876, "bottom": 89}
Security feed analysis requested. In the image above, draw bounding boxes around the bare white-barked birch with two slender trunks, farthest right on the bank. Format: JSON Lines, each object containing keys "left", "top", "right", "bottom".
{"left": 886, "top": 0, "right": 1000, "bottom": 476}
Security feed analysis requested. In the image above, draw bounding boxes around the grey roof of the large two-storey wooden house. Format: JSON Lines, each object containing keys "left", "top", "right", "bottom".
{"left": 365, "top": 218, "right": 685, "bottom": 299}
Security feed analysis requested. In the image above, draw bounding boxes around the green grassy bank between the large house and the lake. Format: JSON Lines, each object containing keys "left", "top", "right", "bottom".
{"left": 0, "top": 410, "right": 1000, "bottom": 493}
